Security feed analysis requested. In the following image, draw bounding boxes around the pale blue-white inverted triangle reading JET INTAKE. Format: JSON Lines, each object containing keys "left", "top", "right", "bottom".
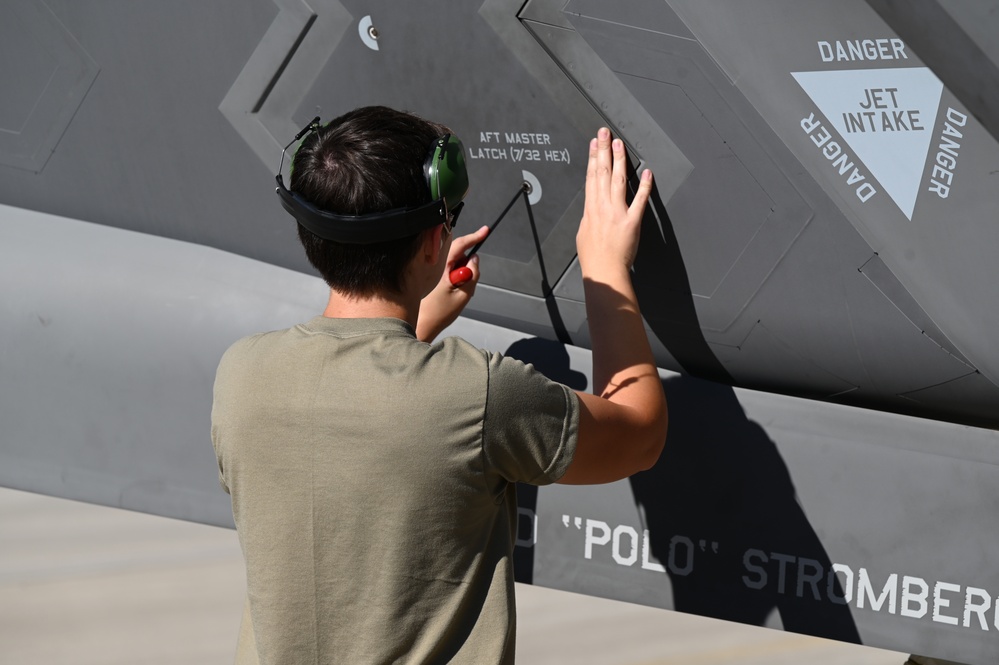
{"left": 791, "top": 67, "right": 943, "bottom": 220}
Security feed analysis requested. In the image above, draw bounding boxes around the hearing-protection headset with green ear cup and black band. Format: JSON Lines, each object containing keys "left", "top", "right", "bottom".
{"left": 275, "top": 116, "right": 468, "bottom": 244}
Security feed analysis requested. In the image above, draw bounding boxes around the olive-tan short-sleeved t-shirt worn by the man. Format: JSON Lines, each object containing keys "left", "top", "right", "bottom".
{"left": 212, "top": 317, "right": 579, "bottom": 664}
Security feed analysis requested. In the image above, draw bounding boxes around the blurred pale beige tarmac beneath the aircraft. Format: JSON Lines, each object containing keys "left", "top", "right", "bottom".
{"left": 0, "top": 488, "right": 907, "bottom": 665}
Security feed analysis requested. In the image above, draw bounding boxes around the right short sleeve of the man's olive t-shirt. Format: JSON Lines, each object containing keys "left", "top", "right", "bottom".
{"left": 483, "top": 354, "right": 579, "bottom": 485}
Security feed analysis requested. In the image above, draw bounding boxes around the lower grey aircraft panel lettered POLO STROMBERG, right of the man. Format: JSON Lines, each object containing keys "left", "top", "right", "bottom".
{"left": 520, "top": 374, "right": 999, "bottom": 663}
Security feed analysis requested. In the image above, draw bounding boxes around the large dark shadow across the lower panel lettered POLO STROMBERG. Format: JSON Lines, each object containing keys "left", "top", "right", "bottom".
{"left": 630, "top": 376, "right": 860, "bottom": 643}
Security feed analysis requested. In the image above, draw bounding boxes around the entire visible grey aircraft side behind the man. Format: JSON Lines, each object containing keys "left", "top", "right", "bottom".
{"left": 0, "top": 0, "right": 999, "bottom": 663}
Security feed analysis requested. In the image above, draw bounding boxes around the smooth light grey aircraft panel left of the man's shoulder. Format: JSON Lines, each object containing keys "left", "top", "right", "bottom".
{"left": 0, "top": 206, "right": 328, "bottom": 525}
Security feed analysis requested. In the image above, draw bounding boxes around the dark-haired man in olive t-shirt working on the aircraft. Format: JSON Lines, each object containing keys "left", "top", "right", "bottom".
{"left": 212, "top": 107, "right": 667, "bottom": 664}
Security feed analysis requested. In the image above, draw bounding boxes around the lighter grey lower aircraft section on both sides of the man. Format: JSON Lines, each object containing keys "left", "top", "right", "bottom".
{"left": 0, "top": 207, "right": 999, "bottom": 663}
